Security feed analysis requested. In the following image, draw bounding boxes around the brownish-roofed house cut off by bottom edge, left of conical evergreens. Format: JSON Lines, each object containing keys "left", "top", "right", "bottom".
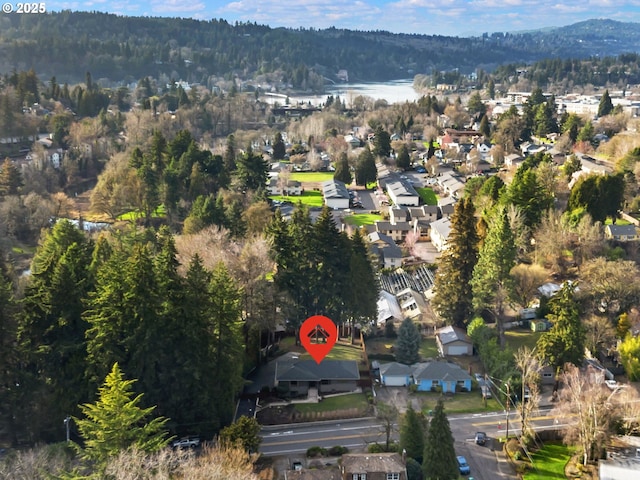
{"left": 340, "top": 453, "right": 407, "bottom": 480}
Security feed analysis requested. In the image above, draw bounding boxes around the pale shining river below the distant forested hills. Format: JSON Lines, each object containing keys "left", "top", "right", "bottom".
{"left": 260, "top": 79, "right": 422, "bottom": 106}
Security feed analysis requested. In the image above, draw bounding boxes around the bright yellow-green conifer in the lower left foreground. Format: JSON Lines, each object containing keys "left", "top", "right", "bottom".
{"left": 74, "top": 363, "right": 168, "bottom": 466}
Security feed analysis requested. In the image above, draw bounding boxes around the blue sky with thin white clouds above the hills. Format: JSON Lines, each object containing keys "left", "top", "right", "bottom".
{"left": 46, "top": 0, "right": 640, "bottom": 36}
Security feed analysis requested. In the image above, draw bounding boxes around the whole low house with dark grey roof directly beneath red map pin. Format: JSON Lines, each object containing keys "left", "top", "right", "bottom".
{"left": 275, "top": 359, "right": 360, "bottom": 396}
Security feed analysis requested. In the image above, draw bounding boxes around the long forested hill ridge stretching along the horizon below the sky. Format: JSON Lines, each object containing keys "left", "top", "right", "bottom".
{"left": 0, "top": 11, "right": 640, "bottom": 87}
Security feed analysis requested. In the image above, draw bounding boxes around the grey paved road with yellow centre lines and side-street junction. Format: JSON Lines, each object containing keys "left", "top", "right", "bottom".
{"left": 260, "top": 410, "right": 562, "bottom": 480}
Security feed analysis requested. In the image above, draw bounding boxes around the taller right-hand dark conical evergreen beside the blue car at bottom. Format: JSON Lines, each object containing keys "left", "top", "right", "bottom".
{"left": 422, "top": 400, "right": 459, "bottom": 480}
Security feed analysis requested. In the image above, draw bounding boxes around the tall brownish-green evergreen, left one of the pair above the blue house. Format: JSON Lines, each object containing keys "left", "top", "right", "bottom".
{"left": 433, "top": 197, "right": 479, "bottom": 327}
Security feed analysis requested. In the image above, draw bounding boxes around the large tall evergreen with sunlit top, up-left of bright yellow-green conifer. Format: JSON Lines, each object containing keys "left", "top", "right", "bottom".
{"left": 18, "top": 220, "right": 93, "bottom": 439}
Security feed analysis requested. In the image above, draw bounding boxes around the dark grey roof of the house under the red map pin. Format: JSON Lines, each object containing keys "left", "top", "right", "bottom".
{"left": 276, "top": 360, "right": 360, "bottom": 382}
